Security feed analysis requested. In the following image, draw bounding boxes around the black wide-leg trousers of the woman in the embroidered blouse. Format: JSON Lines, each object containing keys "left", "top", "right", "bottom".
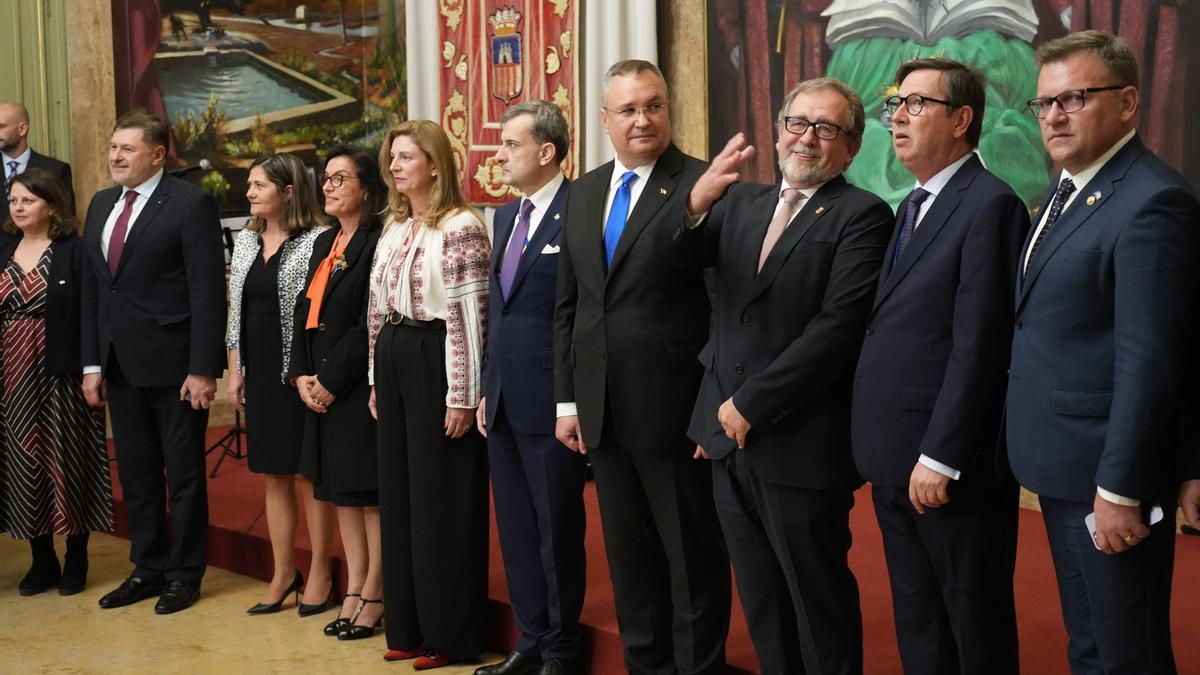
{"left": 374, "top": 323, "right": 488, "bottom": 661}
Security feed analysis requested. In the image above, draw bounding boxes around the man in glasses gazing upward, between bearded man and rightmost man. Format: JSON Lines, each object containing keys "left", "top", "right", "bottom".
{"left": 851, "top": 59, "right": 1030, "bottom": 674}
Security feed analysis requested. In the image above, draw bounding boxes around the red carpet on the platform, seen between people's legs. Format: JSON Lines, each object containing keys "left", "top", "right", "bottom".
{"left": 105, "top": 426, "right": 1200, "bottom": 675}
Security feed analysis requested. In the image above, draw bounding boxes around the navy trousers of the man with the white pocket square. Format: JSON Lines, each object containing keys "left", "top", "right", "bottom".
{"left": 487, "top": 401, "right": 587, "bottom": 659}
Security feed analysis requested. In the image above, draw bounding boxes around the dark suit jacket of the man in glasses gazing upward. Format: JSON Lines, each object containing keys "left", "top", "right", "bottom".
{"left": 852, "top": 155, "right": 1030, "bottom": 488}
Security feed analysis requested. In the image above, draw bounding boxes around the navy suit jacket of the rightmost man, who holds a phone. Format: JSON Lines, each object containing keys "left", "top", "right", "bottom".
{"left": 1007, "top": 137, "right": 1200, "bottom": 507}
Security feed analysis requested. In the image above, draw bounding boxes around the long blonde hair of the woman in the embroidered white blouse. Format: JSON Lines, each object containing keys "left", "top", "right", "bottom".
{"left": 379, "top": 120, "right": 470, "bottom": 228}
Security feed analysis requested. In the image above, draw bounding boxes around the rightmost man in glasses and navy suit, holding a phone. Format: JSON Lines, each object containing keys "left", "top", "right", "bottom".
{"left": 1007, "top": 31, "right": 1200, "bottom": 673}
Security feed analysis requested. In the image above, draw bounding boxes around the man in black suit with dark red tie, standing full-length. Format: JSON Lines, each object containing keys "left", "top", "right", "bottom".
{"left": 82, "top": 109, "right": 226, "bottom": 614}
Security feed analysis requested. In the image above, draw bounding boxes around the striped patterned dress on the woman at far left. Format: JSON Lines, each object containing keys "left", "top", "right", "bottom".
{"left": 0, "top": 249, "right": 113, "bottom": 539}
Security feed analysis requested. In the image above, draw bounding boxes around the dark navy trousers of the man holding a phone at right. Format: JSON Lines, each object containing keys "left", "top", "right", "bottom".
{"left": 1038, "top": 495, "right": 1175, "bottom": 675}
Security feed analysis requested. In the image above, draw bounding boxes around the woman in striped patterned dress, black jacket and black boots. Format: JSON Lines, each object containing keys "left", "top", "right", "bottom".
{"left": 0, "top": 168, "right": 113, "bottom": 596}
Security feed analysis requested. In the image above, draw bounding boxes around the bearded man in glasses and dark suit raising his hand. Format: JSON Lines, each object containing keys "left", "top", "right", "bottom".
{"left": 658, "top": 78, "right": 892, "bottom": 674}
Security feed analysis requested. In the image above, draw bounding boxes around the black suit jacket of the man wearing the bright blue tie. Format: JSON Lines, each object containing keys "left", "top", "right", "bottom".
{"left": 554, "top": 145, "right": 709, "bottom": 452}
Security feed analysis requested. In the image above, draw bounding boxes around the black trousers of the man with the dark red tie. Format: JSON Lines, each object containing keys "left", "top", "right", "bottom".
{"left": 104, "top": 352, "right": 209, "bottom": 581}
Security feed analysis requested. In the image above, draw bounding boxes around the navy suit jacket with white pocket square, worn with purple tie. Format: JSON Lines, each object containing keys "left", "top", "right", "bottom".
{"left": 484, "top": 180, "right": 570, "bottom": 435}
